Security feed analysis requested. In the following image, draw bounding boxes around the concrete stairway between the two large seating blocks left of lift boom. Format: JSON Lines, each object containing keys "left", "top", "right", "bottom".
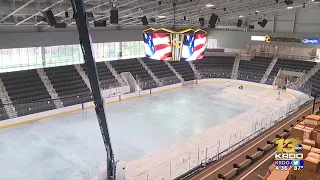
{"left": 37, "top": 68, "right": 64, "bottom": 108}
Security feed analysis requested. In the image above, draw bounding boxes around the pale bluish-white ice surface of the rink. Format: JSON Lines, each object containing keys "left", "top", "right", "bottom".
{"left": 0, "top": 85, "right": 261, "bottom": 180}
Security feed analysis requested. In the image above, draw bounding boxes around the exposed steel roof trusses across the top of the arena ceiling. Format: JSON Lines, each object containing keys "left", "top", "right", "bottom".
{"left": 0, "top": 0, "right": 319, "bottom": 29}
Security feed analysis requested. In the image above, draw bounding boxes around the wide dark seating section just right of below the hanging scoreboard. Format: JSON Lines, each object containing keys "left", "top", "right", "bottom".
{"left": 193, "top": 56, "right": 234, "bottom": 78}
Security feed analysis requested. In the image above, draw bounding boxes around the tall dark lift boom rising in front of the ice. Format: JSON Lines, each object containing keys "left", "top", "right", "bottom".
{"left": 71, "top": 0, "right": 116, "bottom": 180}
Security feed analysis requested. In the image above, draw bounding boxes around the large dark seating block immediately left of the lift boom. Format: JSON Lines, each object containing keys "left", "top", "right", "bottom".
{"left": 44, "top": 65, "right": 92, "bottom": 106}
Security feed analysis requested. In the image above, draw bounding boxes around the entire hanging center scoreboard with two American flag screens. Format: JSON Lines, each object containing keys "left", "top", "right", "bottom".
{"left": 143, "top": 28, "right": 207, "bottom": 61}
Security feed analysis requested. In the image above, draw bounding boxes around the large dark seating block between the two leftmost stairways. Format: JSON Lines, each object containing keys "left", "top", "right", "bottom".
{"left": 0, "top": 69, "right": 56, "bottom": 116}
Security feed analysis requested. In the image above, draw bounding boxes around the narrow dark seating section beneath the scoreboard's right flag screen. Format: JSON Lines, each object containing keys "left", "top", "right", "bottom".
{"left": 170, "top": 61, "right": 195, "bottom": 81}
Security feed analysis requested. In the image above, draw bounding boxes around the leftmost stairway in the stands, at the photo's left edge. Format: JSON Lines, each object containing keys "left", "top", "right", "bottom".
{"left": 0, "top": 79, "right": 18, "bottom": 119}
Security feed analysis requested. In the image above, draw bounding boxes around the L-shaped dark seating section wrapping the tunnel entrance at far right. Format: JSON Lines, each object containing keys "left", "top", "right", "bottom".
{"left": 266, "top": 59, "right": 316, "bottom": 84}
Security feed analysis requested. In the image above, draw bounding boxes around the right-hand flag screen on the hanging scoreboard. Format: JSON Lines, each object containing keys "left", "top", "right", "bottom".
{"left": 181, "top": 34, "right": 207, "bottom": 61}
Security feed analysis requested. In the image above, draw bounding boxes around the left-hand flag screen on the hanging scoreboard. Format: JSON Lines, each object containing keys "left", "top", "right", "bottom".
{"left": 143, "top": 33, "right": 172, "bottom": 60}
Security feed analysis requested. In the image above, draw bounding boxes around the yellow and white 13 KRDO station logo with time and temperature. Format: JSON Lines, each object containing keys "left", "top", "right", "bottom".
{"left": 274, "top": 138, "right": 304, "bottom": 171}
